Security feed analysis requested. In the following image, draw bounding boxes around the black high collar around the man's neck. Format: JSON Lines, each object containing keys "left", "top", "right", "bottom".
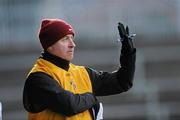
{"left": 40, "top": 51, "right": 70, "bottom": 71}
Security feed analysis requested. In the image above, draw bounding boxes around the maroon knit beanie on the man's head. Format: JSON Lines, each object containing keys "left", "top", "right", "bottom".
{"left": 39, "top": 19, "right": 74, "bottom": 50}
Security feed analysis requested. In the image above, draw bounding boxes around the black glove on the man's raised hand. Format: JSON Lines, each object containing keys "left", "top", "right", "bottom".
{"left": 118, "top": 22, "right": 134, "bottom": 54}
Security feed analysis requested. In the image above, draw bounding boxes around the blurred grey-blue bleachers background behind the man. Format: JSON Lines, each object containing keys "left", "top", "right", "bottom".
{"left": 0, "top": 0, "right": 180, "bottom": 120}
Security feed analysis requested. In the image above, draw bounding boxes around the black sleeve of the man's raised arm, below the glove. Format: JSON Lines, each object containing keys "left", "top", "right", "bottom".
{"left": 86, "top": 49, "right": 136, "bottom": 96}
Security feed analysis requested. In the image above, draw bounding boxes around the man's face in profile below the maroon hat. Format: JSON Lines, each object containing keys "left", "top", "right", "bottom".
{"left": 47, "top": 34, "right": 76, "bottom": 61}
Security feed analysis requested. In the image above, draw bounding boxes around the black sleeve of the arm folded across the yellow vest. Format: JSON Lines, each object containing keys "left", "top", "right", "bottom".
{"left": 23, "top": 72, "right": 97, "bottom": 116}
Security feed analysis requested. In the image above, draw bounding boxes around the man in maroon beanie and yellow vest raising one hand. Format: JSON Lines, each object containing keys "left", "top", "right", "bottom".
{"left": 23, "top": 19, "right": 136, "bottom": 120}
